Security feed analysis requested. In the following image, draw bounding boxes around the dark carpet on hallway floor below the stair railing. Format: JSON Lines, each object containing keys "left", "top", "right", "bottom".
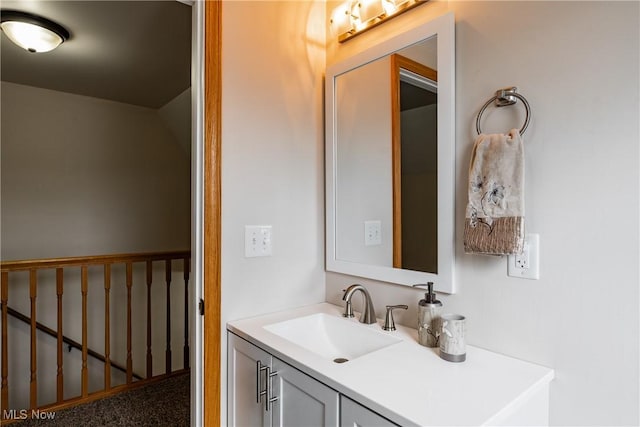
{"left": 14, "top": 373, "right": 190, "bottom": 427}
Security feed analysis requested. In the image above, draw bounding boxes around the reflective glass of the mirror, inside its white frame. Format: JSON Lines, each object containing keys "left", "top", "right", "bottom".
{"left": 335, "top": 36, "right": 438, "bottom": 273}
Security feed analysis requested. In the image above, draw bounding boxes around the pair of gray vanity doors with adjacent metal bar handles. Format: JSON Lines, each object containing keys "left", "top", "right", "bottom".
{"left": 228, "top": 333, "right": 339, "bottom": 427}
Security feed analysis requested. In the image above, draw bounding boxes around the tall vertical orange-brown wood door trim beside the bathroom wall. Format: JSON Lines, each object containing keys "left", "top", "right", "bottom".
{"left": 202, "top": 0, "right": 224, "bottom": 426}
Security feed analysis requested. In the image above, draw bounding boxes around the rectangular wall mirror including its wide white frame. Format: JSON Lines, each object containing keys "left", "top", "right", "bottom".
{"left": 326, "top": 13, "right": 455, "bottom": 293}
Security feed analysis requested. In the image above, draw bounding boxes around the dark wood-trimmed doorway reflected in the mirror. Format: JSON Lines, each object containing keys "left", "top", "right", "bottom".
{"left": 390, "top": 50, "right": 438, "bottom": 273}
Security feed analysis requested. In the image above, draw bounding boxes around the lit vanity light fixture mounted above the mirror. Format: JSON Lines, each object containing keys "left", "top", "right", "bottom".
{"left": 329, "top": 0, "right": 429, "bottom": 43}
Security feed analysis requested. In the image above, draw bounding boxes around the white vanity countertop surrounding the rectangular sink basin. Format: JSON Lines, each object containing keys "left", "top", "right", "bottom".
{"left": 227, "top": 303, "right": 554, "bottom": 426}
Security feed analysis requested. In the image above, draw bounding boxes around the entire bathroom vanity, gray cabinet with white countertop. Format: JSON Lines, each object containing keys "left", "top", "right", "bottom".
{"left": 227, "top": 303, "right": 554, "bottom": 427}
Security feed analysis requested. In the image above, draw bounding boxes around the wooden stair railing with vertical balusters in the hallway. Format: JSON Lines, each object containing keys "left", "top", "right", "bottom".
{"left": 0, "top": 251, "right": 190, "bottom": 419}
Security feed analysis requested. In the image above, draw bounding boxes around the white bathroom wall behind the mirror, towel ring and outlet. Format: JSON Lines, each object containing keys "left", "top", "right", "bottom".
{"left": 326, "top": 1, "right": 640, "bottom": 425}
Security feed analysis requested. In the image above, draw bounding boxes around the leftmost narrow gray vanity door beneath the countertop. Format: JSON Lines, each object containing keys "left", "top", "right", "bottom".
{"left": 228, "top": 333, "right": 272, "bottom": 427}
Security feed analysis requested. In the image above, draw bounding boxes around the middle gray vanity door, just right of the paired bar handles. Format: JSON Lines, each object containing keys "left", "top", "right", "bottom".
{"left": 272, "top": 357, "right": 339, "bottom": 427}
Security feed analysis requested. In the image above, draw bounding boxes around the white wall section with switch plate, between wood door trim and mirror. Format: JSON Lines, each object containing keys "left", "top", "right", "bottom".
{"left": 221, "top": 1, "right": 325, "bottom": 425}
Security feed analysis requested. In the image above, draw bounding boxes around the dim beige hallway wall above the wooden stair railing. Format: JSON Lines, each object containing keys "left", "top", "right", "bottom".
{"left": 1, "top": 82, "right": 190, "bottom": 260}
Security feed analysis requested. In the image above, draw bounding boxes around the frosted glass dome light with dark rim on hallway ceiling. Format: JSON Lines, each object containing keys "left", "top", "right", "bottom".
{"left": 0, "top": 10, "right": 69, "bottom": 53}
